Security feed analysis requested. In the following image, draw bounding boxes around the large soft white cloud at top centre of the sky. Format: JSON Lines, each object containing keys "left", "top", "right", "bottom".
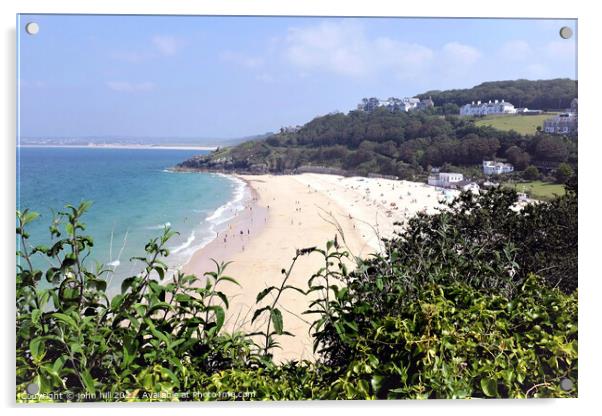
{"left": 283, "top": 20, "right": 433, "bottom": 77}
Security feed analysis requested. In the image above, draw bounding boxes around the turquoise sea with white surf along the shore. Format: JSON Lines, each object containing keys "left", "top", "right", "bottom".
{"left": 17, "top": 147, "right": 246, "bottom": 288}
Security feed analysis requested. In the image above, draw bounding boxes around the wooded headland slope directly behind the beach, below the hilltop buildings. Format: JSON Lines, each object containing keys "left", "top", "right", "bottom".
{"left": 179, "top": 109, "right": 577, "bottom": 179}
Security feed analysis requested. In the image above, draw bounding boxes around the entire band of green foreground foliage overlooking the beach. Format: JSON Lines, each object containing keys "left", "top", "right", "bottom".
{"left": 16, "top": 184, "right": 577, "bottom": 401}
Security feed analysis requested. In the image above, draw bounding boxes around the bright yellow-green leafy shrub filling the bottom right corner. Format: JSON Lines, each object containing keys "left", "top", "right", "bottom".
{"left": 318, "top": 276, "right": 577, "bottom": 399}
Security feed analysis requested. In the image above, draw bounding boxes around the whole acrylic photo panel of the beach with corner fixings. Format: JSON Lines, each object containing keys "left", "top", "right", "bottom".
{"left": 16, "top": 14, "right": 578, "bottom": 403}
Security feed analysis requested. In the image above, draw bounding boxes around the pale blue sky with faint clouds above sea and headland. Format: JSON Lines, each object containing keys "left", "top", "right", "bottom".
{"left": 17, "top": 15, "right": 577, "bottom": 139}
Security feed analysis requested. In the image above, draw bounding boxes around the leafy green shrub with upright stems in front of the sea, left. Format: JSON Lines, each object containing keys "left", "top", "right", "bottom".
{"left": 16, "top": 204, "right": 254, "bottom": 399}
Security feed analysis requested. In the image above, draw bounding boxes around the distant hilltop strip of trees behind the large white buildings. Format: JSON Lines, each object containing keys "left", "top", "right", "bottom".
{"left": 417, "top": 78, "right": 577, "bottom": 110}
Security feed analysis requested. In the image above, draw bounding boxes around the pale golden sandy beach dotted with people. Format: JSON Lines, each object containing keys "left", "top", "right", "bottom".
{"left": 183, "top": 174, "right": 452, "bottom": 361}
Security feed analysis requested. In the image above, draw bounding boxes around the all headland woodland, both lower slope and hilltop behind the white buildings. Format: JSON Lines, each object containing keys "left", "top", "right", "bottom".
{"left": 179, "top": 79, "right": 577, "bottom": 179}
